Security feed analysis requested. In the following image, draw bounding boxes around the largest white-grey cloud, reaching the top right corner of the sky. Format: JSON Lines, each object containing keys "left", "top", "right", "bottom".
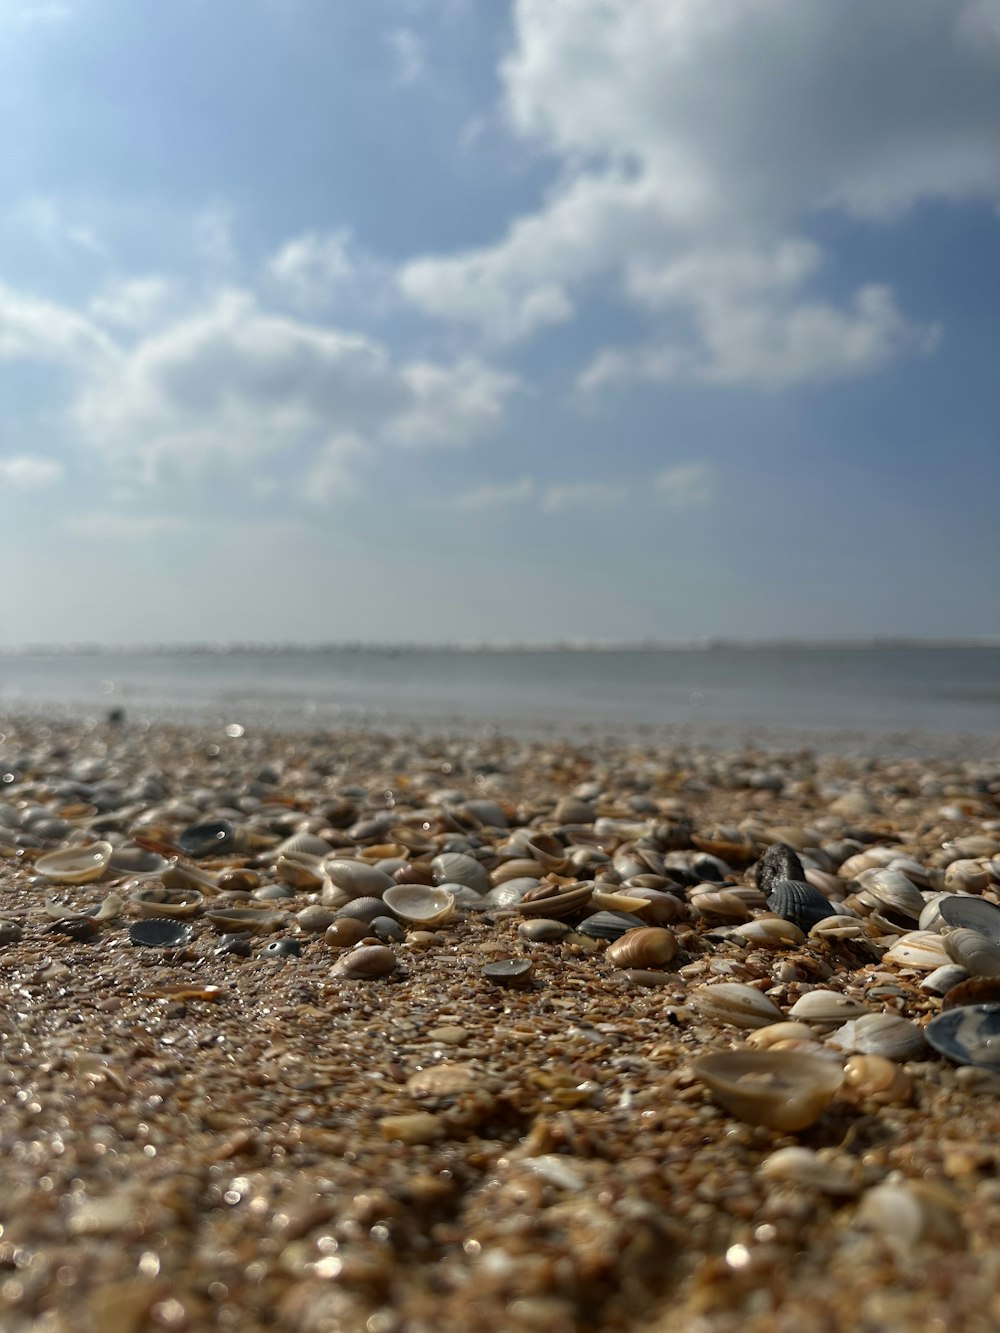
{"left": 400, "top": 0, "right": 1000, "bottom": 388}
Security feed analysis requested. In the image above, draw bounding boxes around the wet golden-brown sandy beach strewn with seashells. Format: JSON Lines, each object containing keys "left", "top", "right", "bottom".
{"left": 0, "top": 712, "right": 1000, "bottom": 1333}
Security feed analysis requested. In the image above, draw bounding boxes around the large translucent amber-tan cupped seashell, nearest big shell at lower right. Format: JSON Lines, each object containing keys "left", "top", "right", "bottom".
{"left": 691, "top": 1050, "right": 844, "bottom": 1133}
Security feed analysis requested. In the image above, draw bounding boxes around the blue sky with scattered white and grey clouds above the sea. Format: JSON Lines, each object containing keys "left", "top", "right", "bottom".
{"left": 0, "top": 0, "right": 1000, "bottom": 648}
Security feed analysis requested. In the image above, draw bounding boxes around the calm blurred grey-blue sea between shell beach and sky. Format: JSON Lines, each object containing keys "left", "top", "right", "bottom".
{"left": 0, "top": 648, "right": 1000, "bottom": 741}
